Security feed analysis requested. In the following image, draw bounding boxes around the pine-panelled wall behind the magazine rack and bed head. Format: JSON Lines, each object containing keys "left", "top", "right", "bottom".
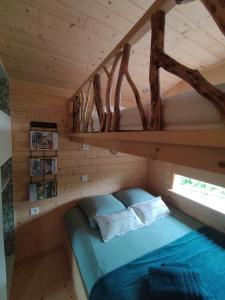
{"left": 11, "top": 80, "right": 147, "bottom": 261}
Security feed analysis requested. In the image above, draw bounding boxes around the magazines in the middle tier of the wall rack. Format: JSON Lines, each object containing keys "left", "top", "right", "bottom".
{"left": 30, "top": 158, "right": 57, "bottom": 176}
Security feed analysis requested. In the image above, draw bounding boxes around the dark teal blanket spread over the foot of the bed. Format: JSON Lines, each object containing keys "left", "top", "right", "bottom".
{"left": 89, "top": 227, "right": 225, "bottom": 300}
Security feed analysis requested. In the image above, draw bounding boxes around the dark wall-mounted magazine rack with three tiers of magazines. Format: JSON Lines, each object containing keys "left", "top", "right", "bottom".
{"left": 29, "top": 122, "right": 58, "bottom": 202}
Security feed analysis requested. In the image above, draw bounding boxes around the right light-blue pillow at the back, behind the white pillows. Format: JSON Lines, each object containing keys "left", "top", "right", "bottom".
{"left": 113, "top": 188, "right": 155, "bottom": 207}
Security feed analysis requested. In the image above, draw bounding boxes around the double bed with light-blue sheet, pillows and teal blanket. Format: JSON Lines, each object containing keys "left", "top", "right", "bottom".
{"left": 64, "top": 188, "right": 225, "bottom": 300}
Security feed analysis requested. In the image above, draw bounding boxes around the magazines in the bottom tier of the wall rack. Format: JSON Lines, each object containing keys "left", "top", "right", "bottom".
{"left": 29, "top": 181, "right": 57, "bottom": 202}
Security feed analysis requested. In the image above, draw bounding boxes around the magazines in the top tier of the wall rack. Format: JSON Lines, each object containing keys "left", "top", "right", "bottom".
{"left": 30, "top": 131, "right": 58, "bottom": 150}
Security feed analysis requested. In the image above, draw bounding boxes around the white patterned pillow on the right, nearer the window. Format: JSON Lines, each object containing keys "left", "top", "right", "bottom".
{"left": 130, "top": 197, "right": 170, "bottom": 226}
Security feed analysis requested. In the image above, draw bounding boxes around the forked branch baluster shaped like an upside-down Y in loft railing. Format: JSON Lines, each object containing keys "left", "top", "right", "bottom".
{"left": 113, "top": 44, "right": 147, "bottom": 131}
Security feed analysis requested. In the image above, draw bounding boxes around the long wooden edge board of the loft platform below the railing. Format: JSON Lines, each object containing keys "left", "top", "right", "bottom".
{"left": 70, "top": 129, "right": 225, "bottom": 174}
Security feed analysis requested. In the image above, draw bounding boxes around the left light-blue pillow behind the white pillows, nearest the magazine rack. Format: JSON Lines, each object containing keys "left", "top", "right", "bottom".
{"left": 78, "top": 195, "right": 125, "bottom": 229}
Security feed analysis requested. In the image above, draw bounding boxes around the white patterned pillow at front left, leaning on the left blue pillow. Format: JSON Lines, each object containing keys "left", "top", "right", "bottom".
{"left": 94, "top": 208, "right": 144, "bottom": 242}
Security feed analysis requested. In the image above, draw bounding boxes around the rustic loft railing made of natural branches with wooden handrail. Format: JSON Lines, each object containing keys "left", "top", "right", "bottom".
{"left": 72, "top": 0, "right": 225, "bottom": 132}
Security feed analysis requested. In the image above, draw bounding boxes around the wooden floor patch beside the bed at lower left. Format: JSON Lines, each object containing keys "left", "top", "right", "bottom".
{"left": 10, "top": 249, "right": 76, "bottom": 300}
